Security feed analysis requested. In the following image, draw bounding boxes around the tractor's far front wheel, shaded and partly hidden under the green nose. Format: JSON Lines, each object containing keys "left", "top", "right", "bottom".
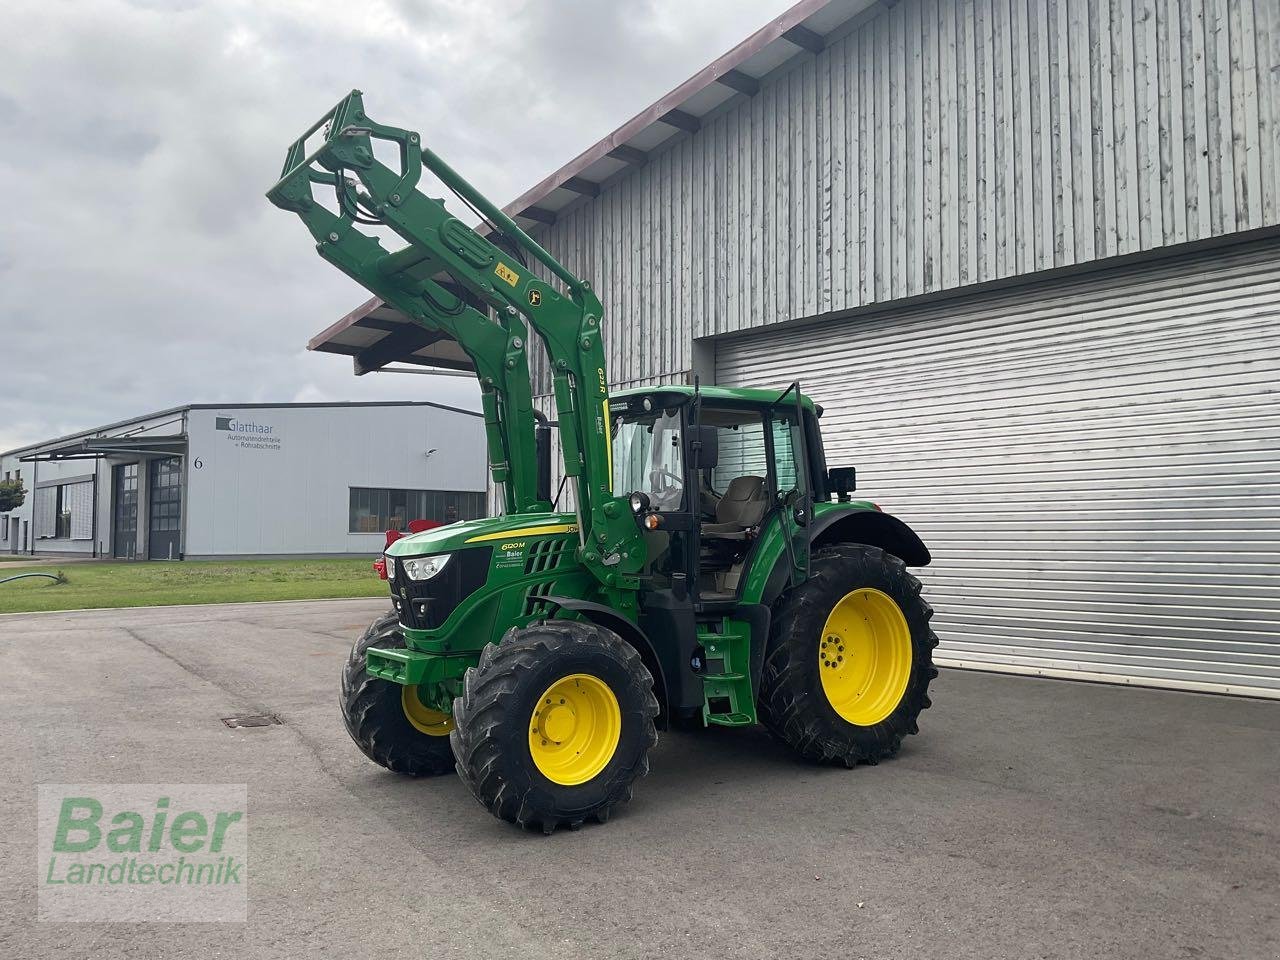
{"left": 338, "top": 613, "right": 453, "bottom": 777}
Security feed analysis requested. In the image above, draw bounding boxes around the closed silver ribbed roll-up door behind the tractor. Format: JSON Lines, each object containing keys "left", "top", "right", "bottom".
{"left": 717, "top": 232, "right": 1280, "bottom": 696}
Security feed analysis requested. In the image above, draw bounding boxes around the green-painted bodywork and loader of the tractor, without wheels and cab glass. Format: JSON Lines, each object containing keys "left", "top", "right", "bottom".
{"left": 268, "top": 91, "right": 931, "bottom": 726}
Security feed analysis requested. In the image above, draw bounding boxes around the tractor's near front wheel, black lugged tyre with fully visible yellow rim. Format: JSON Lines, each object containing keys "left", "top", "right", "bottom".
{"left": 451, "top": 621, "right": 658, "bottom": 833}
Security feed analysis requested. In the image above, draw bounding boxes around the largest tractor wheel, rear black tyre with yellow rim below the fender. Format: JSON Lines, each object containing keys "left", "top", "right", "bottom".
{"left": 760, "top": 544, "right": 938, "bottom": 767}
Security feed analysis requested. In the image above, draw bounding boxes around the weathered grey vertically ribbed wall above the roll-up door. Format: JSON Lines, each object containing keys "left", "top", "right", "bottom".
{"left": 524, "top": 0, "right": 1280, "bottom": 394}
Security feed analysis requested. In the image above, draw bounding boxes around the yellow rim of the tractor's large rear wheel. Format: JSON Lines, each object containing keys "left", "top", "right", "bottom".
{"left": 818, "top": 588, "right": 911, "bottom": 727}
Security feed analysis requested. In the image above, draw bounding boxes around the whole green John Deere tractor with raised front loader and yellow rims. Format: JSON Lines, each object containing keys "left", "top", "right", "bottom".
{"left": 268, "top": 91, "right": 937, "bottom": 833}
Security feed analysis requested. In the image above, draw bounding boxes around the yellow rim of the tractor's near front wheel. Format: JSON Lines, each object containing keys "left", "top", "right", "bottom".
{"left": 529, "top": 673, "right": 622, "bottom": 787}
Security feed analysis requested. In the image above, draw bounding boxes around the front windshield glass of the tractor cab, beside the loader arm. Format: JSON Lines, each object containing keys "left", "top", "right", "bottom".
{"left": 613, "top": 407, "right": 685, "bottom": 511}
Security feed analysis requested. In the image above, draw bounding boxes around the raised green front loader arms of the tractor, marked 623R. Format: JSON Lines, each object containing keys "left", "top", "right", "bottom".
{"left": 268, "top": 91, "right": 645, "bottom": 618}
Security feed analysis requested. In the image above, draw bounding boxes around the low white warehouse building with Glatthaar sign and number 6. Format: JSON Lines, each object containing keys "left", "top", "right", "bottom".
{"left": 0, "top": 403, "right": 486, "bottom": 559}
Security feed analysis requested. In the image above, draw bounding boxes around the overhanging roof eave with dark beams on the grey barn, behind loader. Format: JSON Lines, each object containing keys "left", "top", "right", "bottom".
{"left": 307, "top": 0, "right": 880, "bottom": 376}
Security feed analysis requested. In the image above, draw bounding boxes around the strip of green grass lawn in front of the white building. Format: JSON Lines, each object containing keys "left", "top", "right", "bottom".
{"left": 0, "top": 557, "right": 387, "bottom": 613}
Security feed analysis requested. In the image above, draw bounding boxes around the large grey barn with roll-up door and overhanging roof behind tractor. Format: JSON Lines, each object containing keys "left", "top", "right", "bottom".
{"left": 312, "top": 0, "right": 1280, "bottom": 696}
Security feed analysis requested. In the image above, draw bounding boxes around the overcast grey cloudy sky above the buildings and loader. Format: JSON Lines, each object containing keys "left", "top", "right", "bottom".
{"left": 0, "top": 0, "right": 790, "bottom": 451}
